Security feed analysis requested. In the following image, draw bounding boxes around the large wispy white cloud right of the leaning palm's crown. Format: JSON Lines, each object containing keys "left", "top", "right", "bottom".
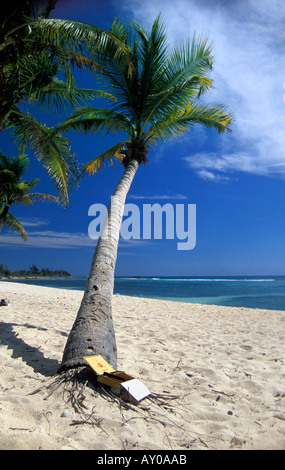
{"left": 121, "top": 0, "right": 285, "bottom": 178}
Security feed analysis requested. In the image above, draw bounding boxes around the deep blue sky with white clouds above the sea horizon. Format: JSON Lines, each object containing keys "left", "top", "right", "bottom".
{"left": 0, "top": 0, "right": 285, "bottom": 276}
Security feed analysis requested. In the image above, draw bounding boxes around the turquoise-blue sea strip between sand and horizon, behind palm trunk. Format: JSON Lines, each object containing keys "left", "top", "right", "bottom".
{"left": 3, "top": 276, "right": 285, "bottom": 310}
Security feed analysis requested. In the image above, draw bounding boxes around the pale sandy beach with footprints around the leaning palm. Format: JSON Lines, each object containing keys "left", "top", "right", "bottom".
{"left": 0, "top": 281, "right": 285, "bottom": 451}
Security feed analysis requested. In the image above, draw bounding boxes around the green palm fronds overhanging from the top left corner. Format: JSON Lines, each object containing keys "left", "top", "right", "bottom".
{"left": 0, "top": 0, "right": 128, "bottom": 205}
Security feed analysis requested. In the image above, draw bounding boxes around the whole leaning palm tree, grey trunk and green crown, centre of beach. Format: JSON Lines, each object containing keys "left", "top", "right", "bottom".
{"left": 56, "top": 16, "right": 232, "bottom": 371}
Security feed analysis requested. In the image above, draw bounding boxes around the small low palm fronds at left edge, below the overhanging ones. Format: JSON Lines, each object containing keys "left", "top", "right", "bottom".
{"left": 0, "top": 154, "right": 58, "bottom": 241}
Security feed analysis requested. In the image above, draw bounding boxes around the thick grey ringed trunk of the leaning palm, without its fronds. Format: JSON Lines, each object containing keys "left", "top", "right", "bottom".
{"left": 59, "top": 160, "right": 139, "bottom": 372}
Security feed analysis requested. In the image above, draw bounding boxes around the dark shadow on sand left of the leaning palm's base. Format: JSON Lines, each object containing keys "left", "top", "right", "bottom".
{"left": 0, "top": 322, "right": 65, "bottom": 377}
